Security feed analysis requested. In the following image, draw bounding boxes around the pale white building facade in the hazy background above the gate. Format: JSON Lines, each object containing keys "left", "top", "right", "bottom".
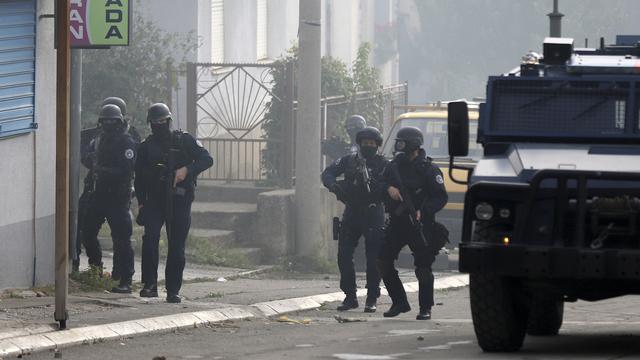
{"left": 138, "top": 0, "right": 399, "bottom": 128}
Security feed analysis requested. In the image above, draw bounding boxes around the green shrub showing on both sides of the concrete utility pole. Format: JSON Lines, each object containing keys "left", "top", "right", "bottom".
{"left": 262, "top": 43, "right": 384, "bottom": 185}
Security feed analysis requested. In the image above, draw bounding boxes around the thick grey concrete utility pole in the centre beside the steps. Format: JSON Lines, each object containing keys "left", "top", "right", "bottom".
{"left": 296, "top": 0, "right": 322, "bottom": 257}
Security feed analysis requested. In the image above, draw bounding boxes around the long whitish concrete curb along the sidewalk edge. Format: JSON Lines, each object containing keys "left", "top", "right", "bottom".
{"left": 0, "top": 275, "right": 469, "bottom": 359}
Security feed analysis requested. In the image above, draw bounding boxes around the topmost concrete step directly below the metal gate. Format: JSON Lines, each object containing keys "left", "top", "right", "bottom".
{"left": 196, "top": 181, "right": 275, "bottom": 204}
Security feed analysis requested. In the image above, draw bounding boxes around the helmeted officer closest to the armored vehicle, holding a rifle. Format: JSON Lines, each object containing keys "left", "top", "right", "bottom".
{"left": 378, "top": 127, "right": 448, "bottom": 320}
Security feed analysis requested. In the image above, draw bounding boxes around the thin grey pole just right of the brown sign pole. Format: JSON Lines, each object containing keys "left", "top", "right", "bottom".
{"left": 69, "top": 49, "right": 82, "bottom": 270}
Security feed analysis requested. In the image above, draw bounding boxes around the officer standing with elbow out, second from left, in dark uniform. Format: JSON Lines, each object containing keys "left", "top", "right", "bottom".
{"left": 135, "top": 103, "right": 213, "bottom": 303}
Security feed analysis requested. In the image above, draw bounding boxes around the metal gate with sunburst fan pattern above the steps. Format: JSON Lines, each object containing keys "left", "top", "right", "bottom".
{"left": 187, "top": 63, "right": 283, "bottom": 181}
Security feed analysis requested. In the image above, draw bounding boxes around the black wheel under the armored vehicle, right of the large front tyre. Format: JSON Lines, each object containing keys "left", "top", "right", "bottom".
{"left": 527, "top": 298, "right": 564, "bottom": 336}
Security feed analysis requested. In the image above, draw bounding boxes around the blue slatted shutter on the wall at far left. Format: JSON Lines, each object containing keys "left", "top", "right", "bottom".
{"left": 0, "top": 0, "right": 37, "bottom": 137}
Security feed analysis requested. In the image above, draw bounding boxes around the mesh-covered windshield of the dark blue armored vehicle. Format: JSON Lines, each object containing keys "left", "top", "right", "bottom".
{"left": 489, "top": 79, "right": 635, "bottom": 136}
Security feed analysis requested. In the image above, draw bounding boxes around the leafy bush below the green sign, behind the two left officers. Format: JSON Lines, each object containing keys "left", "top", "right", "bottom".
{"left": 82, "top": 14, "right": 197, "bottom": 128}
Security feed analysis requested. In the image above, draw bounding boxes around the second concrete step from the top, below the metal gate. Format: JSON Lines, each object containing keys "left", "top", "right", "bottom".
{"left": 191, "top": 202, "right": 257, "bottom": 244}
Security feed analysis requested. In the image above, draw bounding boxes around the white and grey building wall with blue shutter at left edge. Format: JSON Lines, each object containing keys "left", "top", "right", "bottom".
{"left": 0, "top": 0, "right": 56, "bottom": 289}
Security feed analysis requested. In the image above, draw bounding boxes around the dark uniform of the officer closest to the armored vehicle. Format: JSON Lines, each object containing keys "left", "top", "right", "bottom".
{"left": 378, "top": 149, "right": 448, "bottom": 310}
